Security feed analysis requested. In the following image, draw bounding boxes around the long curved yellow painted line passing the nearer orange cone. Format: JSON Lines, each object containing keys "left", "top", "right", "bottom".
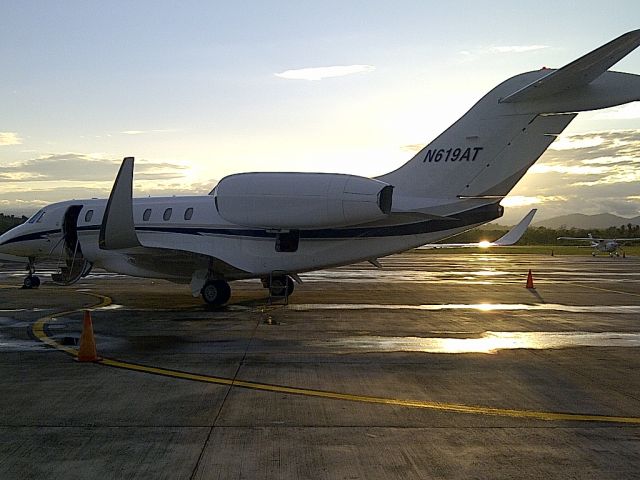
{"left": 33, "top": 292, "right": 640, "bottom": 425}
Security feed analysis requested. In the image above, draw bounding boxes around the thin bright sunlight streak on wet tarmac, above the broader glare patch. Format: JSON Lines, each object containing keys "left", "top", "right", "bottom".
{"left": 287, "top": 303, "right": 640, "bottom": 314}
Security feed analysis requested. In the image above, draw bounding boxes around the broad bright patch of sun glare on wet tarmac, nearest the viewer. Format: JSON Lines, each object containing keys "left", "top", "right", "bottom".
{"left": 320, "top": 332, "right": 640, "bottom": 353}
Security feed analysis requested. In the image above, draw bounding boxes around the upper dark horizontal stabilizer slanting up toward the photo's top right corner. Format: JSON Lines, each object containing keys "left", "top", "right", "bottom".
{"left": 500, "top": 30, "right": 640, "bottom": 103}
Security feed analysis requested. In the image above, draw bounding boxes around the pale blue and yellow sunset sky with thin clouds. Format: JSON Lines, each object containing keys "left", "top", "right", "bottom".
{"left": 0, "top": 0, "right": 640, "bottom": 223}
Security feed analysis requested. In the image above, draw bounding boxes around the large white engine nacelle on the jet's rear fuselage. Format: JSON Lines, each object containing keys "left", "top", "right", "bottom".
{"left": 211, "top": 172, "right": 393, "bottom": 229}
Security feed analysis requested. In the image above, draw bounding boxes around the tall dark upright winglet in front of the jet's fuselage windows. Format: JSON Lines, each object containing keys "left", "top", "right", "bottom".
{"left": 98, "top": 157, "right": 140, "bottom": 250}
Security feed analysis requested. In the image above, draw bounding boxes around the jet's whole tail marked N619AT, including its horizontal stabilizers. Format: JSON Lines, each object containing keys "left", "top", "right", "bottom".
{"left": 378, "top": 30, "right": 640, "bottom": 210}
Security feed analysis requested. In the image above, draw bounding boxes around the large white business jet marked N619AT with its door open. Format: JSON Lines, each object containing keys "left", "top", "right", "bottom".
{"left": 0, "top": 30, "right": 640, "bottom": 305}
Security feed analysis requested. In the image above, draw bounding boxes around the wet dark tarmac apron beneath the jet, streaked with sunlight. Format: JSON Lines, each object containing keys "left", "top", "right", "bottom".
{"left": 0, "top": 250, "right": 640, "bottom": 479}
